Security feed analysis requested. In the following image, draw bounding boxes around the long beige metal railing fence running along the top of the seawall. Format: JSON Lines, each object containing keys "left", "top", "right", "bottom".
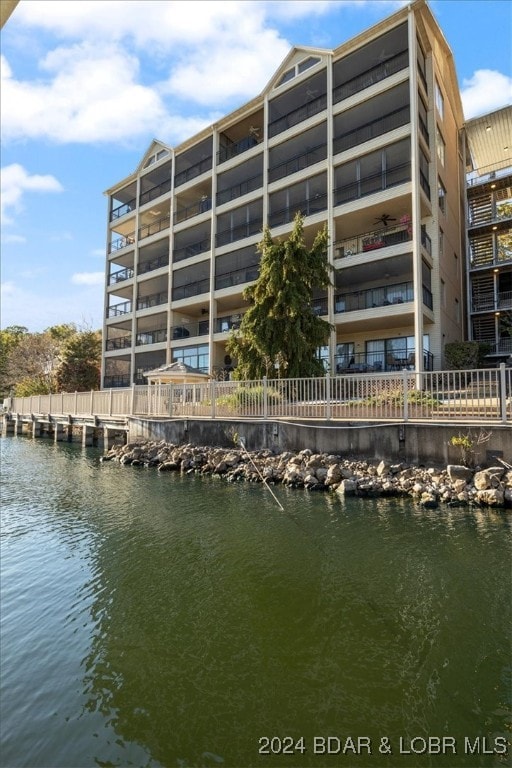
{"left": 10, "top": 364, "right": 512, "bottom": 424}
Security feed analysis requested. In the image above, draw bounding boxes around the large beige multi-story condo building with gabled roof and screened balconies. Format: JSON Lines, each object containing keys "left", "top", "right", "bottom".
{"left": 102, "top": 0, "right": 468, "bottom": 387}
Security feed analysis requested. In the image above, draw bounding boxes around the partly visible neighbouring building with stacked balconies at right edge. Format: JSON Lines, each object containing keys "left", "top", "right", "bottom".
{"left": 465, "top": 106, "right": 512, "bottom": 362}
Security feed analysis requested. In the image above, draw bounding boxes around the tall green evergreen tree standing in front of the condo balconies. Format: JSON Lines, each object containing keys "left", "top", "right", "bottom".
{"left": 227, "top": 213, "right": 331, "bottom": 379}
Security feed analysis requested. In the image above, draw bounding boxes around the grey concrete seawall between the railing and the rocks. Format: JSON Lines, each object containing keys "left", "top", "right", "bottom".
{"left": 128, "top": 418, "right": 512, "bottom": 465}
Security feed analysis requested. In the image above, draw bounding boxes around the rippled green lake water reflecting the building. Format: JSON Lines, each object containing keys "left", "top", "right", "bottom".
{"left": 0, "top": 437, "right": 512, "bottom": 768}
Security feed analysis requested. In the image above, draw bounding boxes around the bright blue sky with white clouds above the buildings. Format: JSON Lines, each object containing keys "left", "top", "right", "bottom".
{"left": 0, "top": 0, "right": 512, "bottom": 331}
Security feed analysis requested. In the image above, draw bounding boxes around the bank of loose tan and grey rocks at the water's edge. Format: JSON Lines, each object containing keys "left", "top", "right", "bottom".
{"left": 100, "top": 439, "right": 512, "bottom": 510}
